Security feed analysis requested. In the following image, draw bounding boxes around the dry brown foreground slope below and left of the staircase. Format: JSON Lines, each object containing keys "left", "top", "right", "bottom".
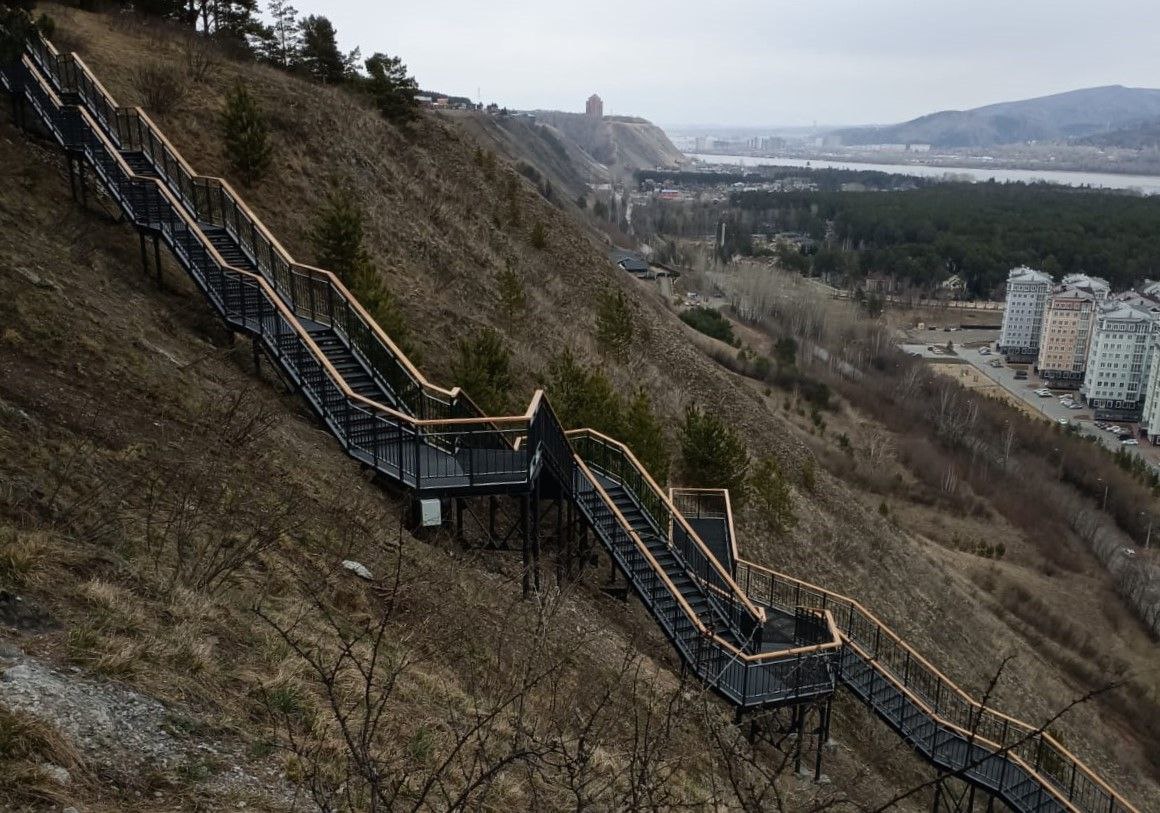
{"left": 0, "top": 119, "right": 890, "bottom": 813}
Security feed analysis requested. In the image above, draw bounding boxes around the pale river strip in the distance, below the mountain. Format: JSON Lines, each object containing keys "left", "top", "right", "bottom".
{"left": 689, "top": 153, "right": 1160, "bottom": 195}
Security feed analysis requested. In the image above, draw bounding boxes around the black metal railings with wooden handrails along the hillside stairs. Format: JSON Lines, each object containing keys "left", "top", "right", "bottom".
{"left": 0, "top": 41, "right": 1134, "bottom": 813}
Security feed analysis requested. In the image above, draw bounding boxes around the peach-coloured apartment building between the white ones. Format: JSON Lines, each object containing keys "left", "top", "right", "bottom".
{"left": 1036, "top": 274, "right": 1110, "bottom": 390}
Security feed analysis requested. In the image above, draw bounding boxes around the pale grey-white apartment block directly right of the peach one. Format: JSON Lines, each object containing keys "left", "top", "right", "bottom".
{"left": 1080, "top": 292, "right": 1160, "bottom": 421}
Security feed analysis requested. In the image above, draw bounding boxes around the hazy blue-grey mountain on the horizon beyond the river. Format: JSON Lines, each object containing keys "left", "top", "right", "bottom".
{"left": 833, "top": 85, "right": 1160, "bottom": 147}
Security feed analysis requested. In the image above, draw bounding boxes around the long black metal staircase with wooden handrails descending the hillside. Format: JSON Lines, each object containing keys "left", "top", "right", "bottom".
{"left": 0, "top": 31, "right": 1134, "bottom": 813}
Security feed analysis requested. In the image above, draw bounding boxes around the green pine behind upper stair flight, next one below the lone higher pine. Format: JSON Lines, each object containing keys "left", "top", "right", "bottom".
{"left": 311, "top": 187, "right": 411, "bottom": 350}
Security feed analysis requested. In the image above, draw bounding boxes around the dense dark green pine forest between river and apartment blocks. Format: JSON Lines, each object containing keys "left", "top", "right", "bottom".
{"left": 732, "top": 183, "right": 1160, "bottom": 297}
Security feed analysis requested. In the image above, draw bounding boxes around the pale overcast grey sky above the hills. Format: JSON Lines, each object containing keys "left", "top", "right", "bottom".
{"left": 313, "top": 0, "right": 1160, "bottom": 125}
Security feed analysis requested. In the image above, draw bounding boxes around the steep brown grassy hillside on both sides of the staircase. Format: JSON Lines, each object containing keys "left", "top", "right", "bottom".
{"left": 0, "top": 6, "right": 1160, "bottom": 810}
